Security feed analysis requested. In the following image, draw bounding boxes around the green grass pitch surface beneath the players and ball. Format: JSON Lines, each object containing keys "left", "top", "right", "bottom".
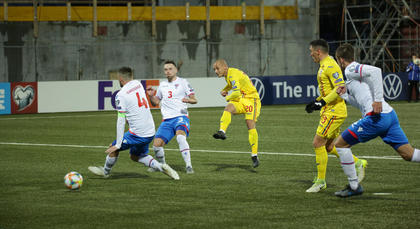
{"left": 0, "top": 102, "right": 420, "bottom": 229}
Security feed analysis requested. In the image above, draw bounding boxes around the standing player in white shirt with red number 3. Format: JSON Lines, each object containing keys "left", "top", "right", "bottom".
{"left": 147, "top": 60, "right": 197, "bottom": 174}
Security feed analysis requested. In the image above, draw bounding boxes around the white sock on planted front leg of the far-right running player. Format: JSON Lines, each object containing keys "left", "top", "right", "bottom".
{"left": 337, "top": 148, "right": 359, "bottom": 190}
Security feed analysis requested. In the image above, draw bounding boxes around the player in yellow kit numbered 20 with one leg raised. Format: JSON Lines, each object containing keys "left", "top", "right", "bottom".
{"left": 213, "top": 59, "right": 261, "bottom": 168}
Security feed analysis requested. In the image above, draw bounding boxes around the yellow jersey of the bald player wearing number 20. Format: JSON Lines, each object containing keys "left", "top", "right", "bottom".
{"left": 222, "top": 68, "right": 260, "bottom": 100}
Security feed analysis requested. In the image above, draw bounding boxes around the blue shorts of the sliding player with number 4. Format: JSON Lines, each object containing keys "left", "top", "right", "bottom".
{"left": 112, "top": 131, "right": 153, "bottom": 156}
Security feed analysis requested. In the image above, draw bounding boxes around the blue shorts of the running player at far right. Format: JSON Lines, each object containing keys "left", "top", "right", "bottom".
{"left": 341, "top": 111, "right": 408, "bottom": 150}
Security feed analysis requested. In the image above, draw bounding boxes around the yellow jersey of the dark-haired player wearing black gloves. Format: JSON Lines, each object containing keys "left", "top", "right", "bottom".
{"left": 316, "top": 56, "right": 347, "bottom": 117}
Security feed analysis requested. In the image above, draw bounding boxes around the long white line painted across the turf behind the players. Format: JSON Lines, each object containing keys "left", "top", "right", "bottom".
{"left": 0, "top": 142, "right": 402, "bottom": 160}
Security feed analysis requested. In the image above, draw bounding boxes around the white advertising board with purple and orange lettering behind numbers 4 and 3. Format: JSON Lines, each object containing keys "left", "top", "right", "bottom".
{"left": 38, "top": 78, "right": 226, "bottom": 113}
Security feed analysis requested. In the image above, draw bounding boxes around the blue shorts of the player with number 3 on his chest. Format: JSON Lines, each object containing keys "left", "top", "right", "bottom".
{"left": 155, "top": 116, "right": 190, "bottom": 144}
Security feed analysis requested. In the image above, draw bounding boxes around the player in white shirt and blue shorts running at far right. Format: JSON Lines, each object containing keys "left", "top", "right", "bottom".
{"left": 335, "top": 44, "right": 420, "bottom": 197}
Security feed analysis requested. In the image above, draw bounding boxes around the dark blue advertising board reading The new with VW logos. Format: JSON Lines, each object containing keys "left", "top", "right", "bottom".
{"left": 250, "top": 72, "right": 408, "bottom": 105}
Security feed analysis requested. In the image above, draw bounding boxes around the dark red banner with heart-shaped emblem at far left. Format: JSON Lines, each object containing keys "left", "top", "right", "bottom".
{"left": 10, "top": 82, "right": 38, "bottom": 114}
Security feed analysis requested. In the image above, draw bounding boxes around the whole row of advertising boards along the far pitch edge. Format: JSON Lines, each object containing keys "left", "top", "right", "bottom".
{"left": 0, "top": 72, "right": 408, "bottom": 114}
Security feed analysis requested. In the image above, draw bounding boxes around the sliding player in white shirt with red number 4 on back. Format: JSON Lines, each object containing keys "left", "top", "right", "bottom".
{"left": 88, "top": 67, "right": 179, "bottom": 180}
